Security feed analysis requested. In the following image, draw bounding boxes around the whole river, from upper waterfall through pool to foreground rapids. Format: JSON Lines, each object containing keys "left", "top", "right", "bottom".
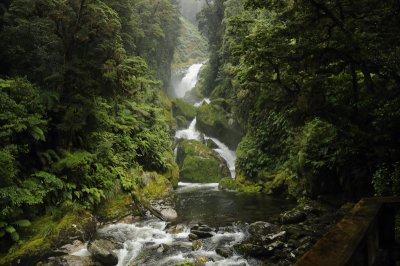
{"left": 76, "top": 64, "right": 293, "bottom": 266}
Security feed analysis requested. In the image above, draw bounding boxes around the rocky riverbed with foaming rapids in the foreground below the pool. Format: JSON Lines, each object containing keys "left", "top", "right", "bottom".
{"left": 34, "top": 202, "right": 352, "bottom": 266}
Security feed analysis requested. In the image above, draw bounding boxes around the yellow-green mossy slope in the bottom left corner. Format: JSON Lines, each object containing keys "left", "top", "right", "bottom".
{"left": 0, "top": 211, "right": 96, "bottom": 265}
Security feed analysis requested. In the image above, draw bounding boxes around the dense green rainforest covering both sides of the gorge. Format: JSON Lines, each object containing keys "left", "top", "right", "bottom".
{"left": 0, "top": 0, "right": 400, "bottom": 265}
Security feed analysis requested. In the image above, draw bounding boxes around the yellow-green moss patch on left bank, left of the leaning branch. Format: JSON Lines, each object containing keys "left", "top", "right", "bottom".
{"left": 96, "top": 193, "right": 134, "bottom": 222}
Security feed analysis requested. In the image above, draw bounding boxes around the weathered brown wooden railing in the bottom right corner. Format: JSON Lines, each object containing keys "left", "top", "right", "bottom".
{"left": 295, "top": 198, "right": 400, "bottom": 266}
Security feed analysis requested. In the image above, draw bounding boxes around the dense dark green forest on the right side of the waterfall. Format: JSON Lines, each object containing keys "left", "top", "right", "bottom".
{"left": 198, "top": 0, "right": 400, "bottom": 198}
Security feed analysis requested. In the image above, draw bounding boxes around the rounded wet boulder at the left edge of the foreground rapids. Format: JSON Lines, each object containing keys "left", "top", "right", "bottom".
{"left": 87, "top": 239, "right": 118, "bottom": 265}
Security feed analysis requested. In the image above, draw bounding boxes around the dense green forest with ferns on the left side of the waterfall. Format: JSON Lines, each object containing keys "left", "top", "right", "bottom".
{"left": 0, "top": 0, "right": 180, "bottom": 252}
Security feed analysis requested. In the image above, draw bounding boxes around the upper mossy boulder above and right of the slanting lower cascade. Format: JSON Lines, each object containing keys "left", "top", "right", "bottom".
{"left": 196, "top": 102, "right": 242, "bottom": 149}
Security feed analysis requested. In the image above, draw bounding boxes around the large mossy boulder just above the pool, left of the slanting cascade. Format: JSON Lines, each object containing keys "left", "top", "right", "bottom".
{"left": 177, "top": 140, "right": 230, "bottom": 183}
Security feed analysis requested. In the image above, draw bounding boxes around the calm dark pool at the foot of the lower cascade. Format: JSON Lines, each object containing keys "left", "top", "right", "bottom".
{"left": 175, "top": 182, "right": 295, "bottom": 226}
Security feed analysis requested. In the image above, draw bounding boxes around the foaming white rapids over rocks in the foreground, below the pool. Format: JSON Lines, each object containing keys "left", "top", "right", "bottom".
{"left": 98, "top": 220, "right": 249, "bottom": 266}
